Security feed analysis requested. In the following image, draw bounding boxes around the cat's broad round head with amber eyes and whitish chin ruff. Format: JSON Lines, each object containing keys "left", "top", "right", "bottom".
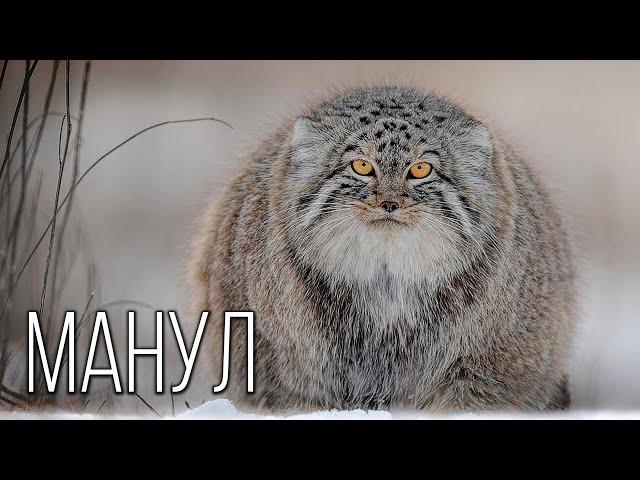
{"left": 285, "top": 88, "right": 499, "bottom": 281}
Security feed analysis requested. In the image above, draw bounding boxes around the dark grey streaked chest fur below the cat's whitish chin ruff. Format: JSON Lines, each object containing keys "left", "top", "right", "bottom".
{"left": 272, "top": 268, "right": 450, "bottom": 408}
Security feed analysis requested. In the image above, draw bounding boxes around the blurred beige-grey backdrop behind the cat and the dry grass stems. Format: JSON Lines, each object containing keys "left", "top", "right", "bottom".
{"left": 0, "top": 60, "right": 640, "bottom": 411}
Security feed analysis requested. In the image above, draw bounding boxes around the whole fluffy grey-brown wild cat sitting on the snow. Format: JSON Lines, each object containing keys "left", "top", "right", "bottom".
{"left": 192, "top": 88, "right": 574, "bottom": 410}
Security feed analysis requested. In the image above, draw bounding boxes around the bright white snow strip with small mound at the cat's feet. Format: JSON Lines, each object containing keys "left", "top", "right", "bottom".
{"left": 176, "top": 399, "right": 392, "bottom": 420}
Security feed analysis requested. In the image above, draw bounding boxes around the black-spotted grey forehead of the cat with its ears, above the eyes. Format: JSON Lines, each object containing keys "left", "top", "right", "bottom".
{"left": 292, "top": 88, "right": 492, "bottom": 171}
